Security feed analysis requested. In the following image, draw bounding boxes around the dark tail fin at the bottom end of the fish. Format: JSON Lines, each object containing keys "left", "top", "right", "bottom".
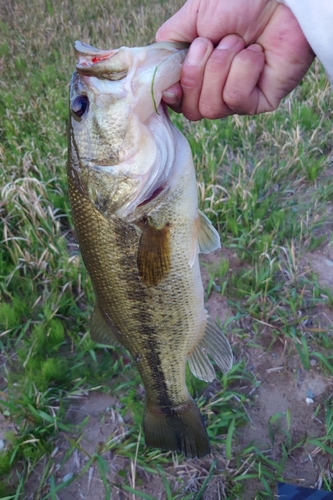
{"left": 143, "top": 399, "right": 210, "bottom": 458}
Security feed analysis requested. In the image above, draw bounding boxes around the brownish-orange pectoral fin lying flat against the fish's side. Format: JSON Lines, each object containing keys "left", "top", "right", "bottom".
{"left": 138, "top": 222, "right": 171, "bottom": 286}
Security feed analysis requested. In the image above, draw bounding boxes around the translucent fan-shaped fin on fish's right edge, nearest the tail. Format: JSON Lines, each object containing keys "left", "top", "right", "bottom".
{"left": 188, "top": 318, "right": 233, "bottom": 382}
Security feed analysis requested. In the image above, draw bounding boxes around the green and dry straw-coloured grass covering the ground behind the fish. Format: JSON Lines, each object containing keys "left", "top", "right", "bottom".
{"left": 0, "top": 0, "right": 333, "bottom": 500}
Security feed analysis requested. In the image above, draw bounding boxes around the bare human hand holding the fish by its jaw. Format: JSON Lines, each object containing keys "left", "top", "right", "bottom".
{"left": 156, "top": 0, "right": 314, "bottom": 120}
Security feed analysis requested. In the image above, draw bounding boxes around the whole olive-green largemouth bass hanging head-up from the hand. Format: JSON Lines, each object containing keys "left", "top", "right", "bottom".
{"left": 67, "top": 41, "right": 233, "bottom": 457}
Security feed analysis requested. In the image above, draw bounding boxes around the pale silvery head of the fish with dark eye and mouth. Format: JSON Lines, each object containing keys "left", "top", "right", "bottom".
{"left": 69, "top": 42, "right": 188, "bottom": 215}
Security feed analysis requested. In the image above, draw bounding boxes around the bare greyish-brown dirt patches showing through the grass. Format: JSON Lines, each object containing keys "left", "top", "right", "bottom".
{"left": 0, "top": 245, "right": 333, "bottom": 500}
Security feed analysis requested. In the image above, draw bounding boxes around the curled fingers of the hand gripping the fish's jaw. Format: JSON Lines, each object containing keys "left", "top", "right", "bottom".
{"left": 163, "top": 35, "right": 266, "bottom": 121}
